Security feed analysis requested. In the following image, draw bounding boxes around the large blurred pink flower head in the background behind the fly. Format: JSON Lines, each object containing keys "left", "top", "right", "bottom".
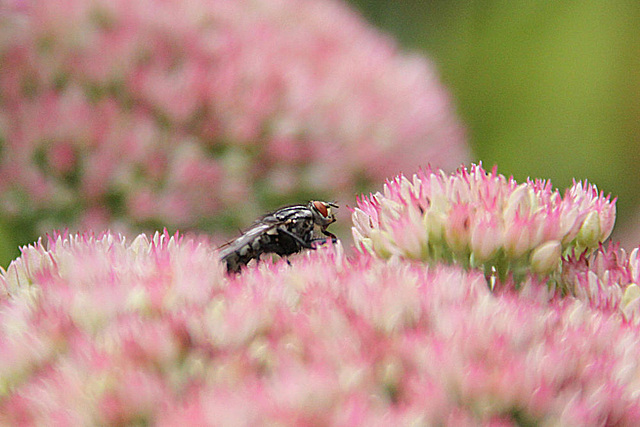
{"left": 0, "top": 0, "right": 467, "bottom": 237}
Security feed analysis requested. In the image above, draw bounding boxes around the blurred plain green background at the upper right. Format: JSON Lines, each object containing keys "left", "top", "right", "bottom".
{"left": 351, "top": 0, "right": 640, "bottom": 246}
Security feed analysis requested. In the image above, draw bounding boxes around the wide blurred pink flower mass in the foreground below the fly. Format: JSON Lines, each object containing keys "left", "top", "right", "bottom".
{"left": 0, "top": 234, "right": 640, "bottom": 426}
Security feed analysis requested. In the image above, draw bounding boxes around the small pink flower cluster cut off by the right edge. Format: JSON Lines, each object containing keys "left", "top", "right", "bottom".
{"left": 558, "top": 244, "right": 640, "bottom": 324}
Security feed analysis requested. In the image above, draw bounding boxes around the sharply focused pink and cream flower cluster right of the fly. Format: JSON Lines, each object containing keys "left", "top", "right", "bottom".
{"left": 353, "top": 165, "right": 615, "bottom": 280}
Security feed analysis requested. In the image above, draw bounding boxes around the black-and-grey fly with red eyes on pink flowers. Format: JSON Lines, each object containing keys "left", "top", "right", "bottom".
{"left": 220, "top": 200, "right": 338, "bottom": 273}
